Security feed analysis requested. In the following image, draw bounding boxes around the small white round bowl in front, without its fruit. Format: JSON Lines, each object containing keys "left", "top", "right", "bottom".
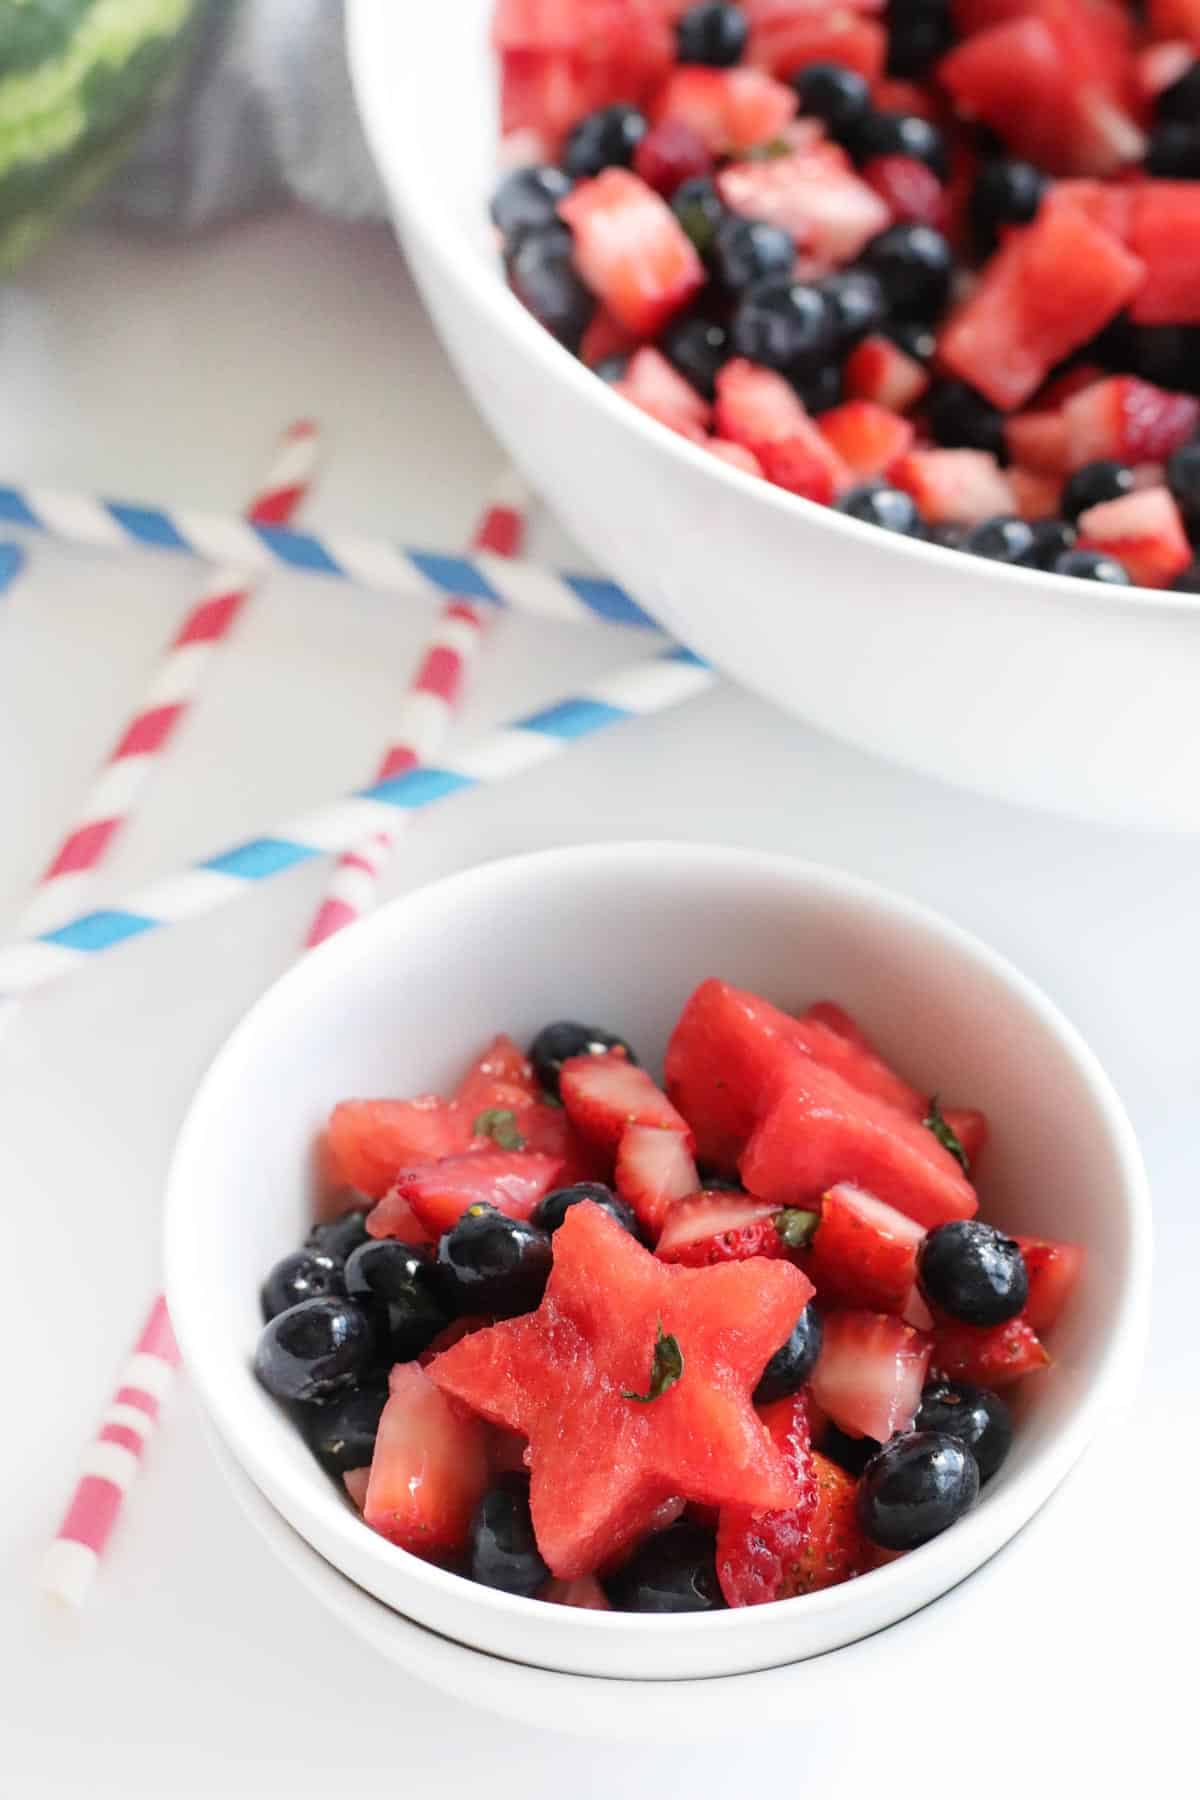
{"left": 167, "top": 844, "right": 1150, "bottom": 1679}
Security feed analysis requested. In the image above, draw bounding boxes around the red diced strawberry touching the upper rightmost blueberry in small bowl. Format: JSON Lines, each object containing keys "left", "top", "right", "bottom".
{"left": 804, "top": 1183, "right": 925, "bottom": 1314}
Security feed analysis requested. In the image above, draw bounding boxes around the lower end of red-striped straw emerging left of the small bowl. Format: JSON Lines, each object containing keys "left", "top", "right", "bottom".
{"left": 41, "top": 1296, "right": 180, "bottom": 1606}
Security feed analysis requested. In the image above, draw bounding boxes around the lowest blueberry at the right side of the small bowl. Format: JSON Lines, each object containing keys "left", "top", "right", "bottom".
{"left": 858, "top": 1431, "right": 979, "bottom": 1550}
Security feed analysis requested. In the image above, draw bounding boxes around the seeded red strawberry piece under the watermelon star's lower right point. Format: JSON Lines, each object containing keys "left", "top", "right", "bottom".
{"left": 716, "top": 1393, "right": 817, "bottom": 1606}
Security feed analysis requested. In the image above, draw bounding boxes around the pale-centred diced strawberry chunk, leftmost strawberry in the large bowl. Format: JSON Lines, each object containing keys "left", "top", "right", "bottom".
{"left": 558, "top": 169, "right": 703, "bottom": 337}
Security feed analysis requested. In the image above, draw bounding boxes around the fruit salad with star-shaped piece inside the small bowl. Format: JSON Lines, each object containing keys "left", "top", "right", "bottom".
{"left": 255, "top": 979, "right": 1083, "bottom": 1613}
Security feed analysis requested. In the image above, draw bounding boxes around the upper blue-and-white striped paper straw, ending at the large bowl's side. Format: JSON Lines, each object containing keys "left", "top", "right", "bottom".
{"left": 0, "top": 486, "right": 658, "bottom": 630}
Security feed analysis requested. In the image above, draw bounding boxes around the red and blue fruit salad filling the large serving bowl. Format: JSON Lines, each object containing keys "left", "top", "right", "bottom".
{"left": 491, "top": 0, "right": 1200, "bottom": 594}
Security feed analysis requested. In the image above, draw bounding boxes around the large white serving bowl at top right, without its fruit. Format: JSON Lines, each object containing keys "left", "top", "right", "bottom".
{"left": 349, "top": 0, "right": 1200, "bottom": 830}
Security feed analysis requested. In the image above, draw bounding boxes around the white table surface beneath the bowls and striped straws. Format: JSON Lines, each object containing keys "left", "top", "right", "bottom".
{"left": 0, "top": 216, "right": 1200, "bottom": 1800}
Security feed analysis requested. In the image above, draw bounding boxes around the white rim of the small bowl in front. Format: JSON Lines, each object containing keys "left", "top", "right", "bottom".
{"left": 166, "top": 839, "right": 1151, "bottom": 1656}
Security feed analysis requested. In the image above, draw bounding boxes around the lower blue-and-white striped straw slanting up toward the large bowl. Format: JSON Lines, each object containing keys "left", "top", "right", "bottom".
{"left": 0, "top": 644, "right": 716, "bottom": 1001}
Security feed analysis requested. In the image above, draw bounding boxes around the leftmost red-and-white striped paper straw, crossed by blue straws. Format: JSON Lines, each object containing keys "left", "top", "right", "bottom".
{"left": 16, "top": 419, "right": 317, "bottom": 936}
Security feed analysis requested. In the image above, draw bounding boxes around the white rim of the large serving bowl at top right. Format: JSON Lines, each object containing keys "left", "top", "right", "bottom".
{"left": 345, "top": 0, "right": 1200, "bottom": 616}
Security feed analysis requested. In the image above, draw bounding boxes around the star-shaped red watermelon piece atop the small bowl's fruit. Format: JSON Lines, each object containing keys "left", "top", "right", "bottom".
{"left": 428, "top": 1202, "right": 813, "bottom": 1580}
